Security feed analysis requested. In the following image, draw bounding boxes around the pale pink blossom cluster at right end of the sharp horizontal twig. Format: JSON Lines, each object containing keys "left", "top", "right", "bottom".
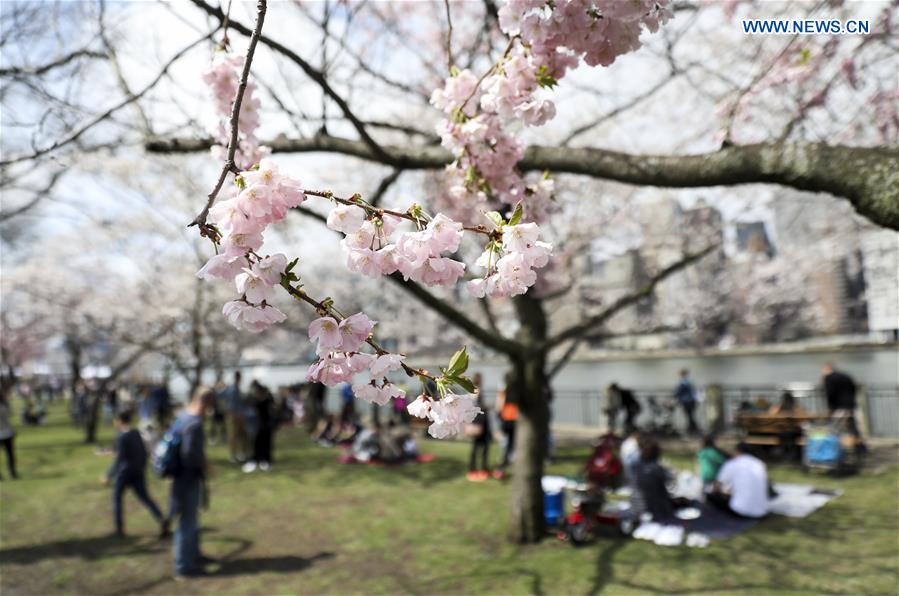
{"left": 467, "top": 222, "right": 552, "bottom": 298}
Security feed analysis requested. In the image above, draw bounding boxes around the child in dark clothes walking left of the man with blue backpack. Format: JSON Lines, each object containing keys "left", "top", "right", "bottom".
{"left": 103, "top": 411, "right": 169, "bottom": 538}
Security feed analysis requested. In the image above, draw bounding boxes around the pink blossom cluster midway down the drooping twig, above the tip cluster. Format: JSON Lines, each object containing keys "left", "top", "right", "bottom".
{"left": 306, "top": 313, "right": 406, "bottom": 406}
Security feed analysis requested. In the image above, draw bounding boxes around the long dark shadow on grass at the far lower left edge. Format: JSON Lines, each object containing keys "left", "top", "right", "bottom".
{"left": 0, "top": 536, "right": 166, "bottom": 565}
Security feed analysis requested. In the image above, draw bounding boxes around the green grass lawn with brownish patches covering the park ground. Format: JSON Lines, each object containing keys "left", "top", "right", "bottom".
{"left": 0, "top": 408, "right": 899, "bottom": 596}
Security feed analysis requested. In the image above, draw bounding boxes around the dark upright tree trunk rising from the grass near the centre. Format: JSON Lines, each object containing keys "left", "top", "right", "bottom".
{"left": 507, "top": 295, "right": 549, "bottom": 544}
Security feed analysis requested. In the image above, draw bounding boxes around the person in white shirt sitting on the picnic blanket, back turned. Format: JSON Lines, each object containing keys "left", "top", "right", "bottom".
{"left": 706, "top": 442, "right": 769, "bottom": 519}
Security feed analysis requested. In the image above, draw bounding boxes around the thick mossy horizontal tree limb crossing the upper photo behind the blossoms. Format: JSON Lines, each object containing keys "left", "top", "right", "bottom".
{"left": 146, "top": 135, "right": 899, "bottom": 230}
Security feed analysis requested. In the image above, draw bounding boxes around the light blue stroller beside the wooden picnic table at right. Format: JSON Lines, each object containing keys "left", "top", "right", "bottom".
{"left": 802, "top": 412, "right": 861, "bottom": 473}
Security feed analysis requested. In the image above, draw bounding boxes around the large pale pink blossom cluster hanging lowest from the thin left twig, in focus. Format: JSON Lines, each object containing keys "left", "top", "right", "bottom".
{"left": 197, "top": 159, "right": 305, "bottom": 333}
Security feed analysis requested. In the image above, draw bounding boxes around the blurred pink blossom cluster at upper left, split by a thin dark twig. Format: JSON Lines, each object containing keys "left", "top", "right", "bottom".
{"left": 203, "top": 52, "right": 270, "bottom": 169}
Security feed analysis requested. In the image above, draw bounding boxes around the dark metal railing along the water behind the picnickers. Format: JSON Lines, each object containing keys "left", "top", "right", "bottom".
{"left": 552, "top": 384, "right": 899, "bottom": 437}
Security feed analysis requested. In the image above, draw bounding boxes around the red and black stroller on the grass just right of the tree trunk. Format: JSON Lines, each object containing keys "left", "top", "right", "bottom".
{"left": 558, "top": 434, "right": 633, "bottom": 546}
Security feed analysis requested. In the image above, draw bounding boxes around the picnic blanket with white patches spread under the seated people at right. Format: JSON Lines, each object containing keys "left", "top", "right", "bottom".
{"left": 633, "top": 483, "right": 842, "bottom": 548}
